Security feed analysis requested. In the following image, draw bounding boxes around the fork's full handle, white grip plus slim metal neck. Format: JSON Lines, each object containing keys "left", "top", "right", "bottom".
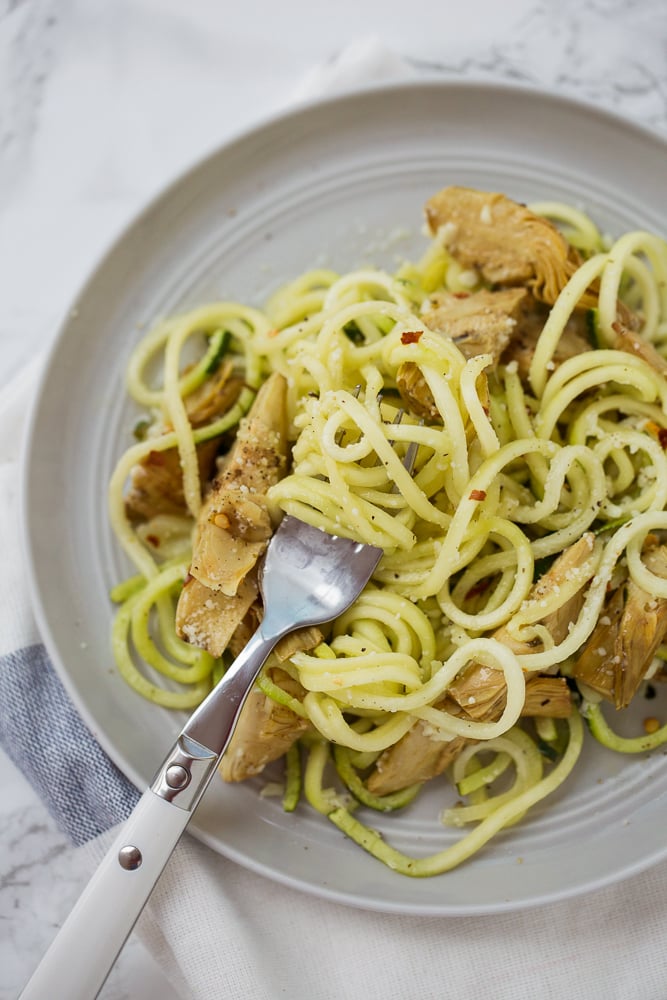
{"left": 21, "top": 614, "right": 285, "bottom": 1000}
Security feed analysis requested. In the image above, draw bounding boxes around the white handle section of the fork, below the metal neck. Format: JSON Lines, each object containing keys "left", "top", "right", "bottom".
{"left": 21, "top": 789, "right": 192, "bottom": 1000}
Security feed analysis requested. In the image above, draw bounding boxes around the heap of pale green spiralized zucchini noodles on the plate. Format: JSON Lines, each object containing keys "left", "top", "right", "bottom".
{"left": 109, "top": 188, "right": 667, "bottom": 876}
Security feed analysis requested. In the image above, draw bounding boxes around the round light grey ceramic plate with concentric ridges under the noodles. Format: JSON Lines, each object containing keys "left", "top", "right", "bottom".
{"left": 24, "top": 83, "right": 667, "bottom": 915}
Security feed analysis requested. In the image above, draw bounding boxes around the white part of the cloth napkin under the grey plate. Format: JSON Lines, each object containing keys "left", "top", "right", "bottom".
{"left": 7, "top": 39, "right": 667, "bottom": 1000}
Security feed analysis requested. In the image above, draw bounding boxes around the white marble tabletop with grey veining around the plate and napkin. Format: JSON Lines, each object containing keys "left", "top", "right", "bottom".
{"left": 0, "top": 0, "right": 667, "bottom": 1000}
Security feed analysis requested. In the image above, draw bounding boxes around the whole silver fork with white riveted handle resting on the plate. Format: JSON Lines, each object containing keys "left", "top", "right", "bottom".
{"left": 21, "top": 434, "right": 417, "bottom": 1000}
